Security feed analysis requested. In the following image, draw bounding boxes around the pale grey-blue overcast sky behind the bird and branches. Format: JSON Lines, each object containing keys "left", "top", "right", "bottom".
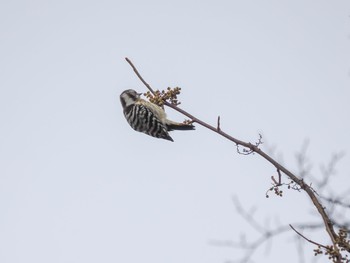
{"left": 0, "top": 0, "right": 350, "bottom": 263}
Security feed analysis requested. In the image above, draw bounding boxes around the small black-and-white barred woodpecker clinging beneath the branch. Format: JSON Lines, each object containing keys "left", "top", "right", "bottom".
{"left": 120, "top": 89, "right": 195, "bottom": 142}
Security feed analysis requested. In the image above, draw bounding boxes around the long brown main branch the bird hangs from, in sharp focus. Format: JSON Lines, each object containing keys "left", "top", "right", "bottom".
{"left": 125, "top": 58, "right": 341, "bottom": 262}
